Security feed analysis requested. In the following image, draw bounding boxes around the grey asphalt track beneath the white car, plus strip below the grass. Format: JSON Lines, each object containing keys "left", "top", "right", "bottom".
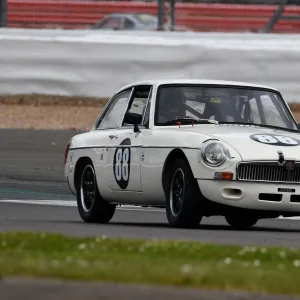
{"left": 0, "top": 129, "right": 300, "bottom": 300}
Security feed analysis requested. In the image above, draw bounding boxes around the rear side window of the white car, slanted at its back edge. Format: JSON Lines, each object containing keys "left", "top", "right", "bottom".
{"left": 98, "top": 90, "right": 131, "bottom": 129}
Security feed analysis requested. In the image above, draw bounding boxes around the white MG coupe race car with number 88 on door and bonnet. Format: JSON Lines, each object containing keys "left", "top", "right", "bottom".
{"left": 65, "top": 80, "right": 300, "bottom": 228}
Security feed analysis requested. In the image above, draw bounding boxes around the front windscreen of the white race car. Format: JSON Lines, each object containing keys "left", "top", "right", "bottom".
{"left": 155, "top": 85, "right": 297, "bottom": 130}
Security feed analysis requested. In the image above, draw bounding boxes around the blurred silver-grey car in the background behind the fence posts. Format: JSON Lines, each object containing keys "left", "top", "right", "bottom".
{"left": 92, "top": 13, "right": 190, "bottom": 31}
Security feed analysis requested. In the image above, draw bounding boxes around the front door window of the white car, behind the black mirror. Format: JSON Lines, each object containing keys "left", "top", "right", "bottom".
{"left": 123, "top": 86, "right": 151, "bottom": 125}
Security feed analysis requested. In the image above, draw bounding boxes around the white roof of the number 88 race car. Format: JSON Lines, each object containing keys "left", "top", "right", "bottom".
{"left": 116, "top": 79, "right": 278, "bottom": 93}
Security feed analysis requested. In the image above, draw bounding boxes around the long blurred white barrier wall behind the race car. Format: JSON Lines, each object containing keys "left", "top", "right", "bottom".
{"left": 0, "top": 29, "right": 300, "bottom": 103}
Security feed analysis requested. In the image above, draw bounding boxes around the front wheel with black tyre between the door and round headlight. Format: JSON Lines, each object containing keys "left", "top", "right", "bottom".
{"left": 165, "top": 158, "right": 202, "bottom": 228}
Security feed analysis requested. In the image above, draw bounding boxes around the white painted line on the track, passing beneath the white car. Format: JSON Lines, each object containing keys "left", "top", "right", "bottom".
{"left": 0, "top": 199, "right": 164, "bottom": 212}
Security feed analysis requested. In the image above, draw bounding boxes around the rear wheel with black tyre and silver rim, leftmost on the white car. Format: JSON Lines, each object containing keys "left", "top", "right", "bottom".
{"left": 77, "top": 163, "right": 116, "bottom": 223}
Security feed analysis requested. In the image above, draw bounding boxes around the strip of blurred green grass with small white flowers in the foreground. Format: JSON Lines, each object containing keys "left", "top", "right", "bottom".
{"left": 0, "top": 232, "right": 300, "bottom": 294}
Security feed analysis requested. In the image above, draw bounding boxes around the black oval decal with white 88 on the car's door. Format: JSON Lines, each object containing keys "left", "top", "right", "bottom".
{"left": 113, "top": 140, "right": 130, "bottom": 189}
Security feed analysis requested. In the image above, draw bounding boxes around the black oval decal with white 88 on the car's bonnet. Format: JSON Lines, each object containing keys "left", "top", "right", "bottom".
{"left": 250, "top": 134, "right": 300, "bottom": 146}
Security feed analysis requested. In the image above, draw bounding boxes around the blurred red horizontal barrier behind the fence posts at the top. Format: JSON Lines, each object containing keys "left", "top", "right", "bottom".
{"left": 3, "top": 0, "right": 300, "bottom": 33}
